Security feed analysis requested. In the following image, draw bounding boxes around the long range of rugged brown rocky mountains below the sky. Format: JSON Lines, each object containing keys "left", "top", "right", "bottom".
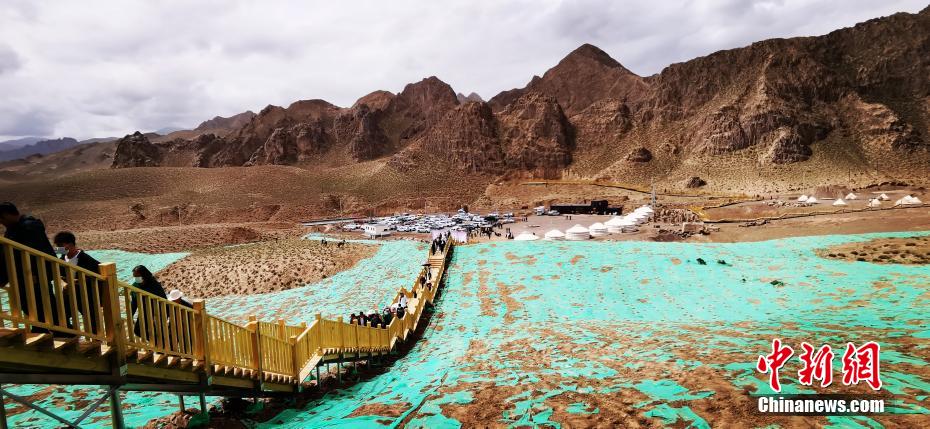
{"left": 113, "top": 8, "right": 930, "bottom": 189}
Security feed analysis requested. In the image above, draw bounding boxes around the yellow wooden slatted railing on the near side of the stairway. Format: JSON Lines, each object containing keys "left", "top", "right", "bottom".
{"left": 0, "top": 238, "right": 452, "bottom": 390}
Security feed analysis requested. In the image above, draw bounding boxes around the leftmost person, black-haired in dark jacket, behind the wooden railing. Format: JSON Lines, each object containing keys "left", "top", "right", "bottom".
{"left": 0, "top": 202, "right": 59, "bottom": 332}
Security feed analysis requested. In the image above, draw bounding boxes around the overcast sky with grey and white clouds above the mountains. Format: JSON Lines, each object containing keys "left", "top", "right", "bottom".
{"left": 0, "top": 0, "right": 927, "bottom": 139}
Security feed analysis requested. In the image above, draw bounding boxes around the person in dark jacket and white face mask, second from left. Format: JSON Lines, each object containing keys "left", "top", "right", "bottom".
{"left": 52, "top": 231, "right": 106, "bottom": 334}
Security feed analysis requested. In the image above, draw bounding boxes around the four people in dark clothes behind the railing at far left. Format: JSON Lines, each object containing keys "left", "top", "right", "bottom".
{"left": 0, "top": 202, "right": 193, "bottom": 336}
